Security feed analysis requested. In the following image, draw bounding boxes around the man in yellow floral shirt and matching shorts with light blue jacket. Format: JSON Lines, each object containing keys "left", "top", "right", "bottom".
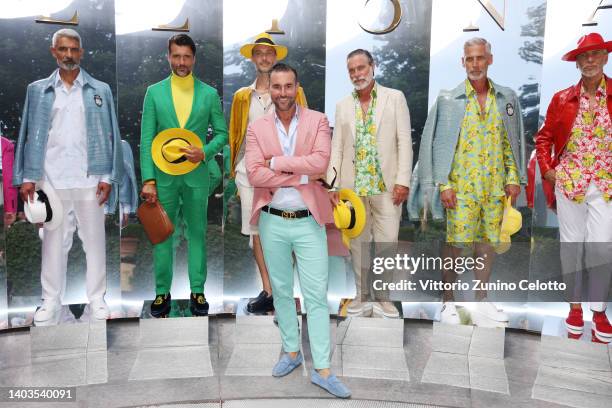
{"left": 416, "top": 38, "right": 526, "bottom": 326}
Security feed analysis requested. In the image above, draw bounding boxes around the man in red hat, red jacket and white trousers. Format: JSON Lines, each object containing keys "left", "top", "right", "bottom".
{"left": 536, "top": 33, "right": 612, "bottom": 343}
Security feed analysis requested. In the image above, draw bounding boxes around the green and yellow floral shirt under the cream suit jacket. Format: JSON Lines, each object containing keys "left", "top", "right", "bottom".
{"left": 353, "top": 85, "right": 387, "bottom": 197}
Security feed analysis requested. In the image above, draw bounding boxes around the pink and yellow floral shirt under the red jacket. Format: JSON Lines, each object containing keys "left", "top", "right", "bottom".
{"left": 555, "top": 78, "right": 612, "bottom": 203}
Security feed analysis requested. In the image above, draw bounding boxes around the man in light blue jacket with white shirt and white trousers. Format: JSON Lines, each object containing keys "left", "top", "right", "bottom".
{"left": 13, "top": 29, "right": 123, "bottom": 325}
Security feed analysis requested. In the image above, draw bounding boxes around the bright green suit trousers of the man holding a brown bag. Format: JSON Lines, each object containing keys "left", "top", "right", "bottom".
{"left": 153, "top": 176, "right": 208, "bottom": 295}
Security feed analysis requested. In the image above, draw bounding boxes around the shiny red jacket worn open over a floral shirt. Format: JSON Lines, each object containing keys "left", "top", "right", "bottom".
{"left": 535, "top": 76, "right": 612, "bottom": 177}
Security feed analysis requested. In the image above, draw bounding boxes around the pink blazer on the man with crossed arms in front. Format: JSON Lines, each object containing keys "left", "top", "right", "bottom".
{"left": 245, "top": 107, "right": 334, "bottom": 225}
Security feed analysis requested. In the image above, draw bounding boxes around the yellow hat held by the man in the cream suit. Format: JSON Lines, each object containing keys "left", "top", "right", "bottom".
{"left": 334, "top": 188, "right": 366, "bottom": 248}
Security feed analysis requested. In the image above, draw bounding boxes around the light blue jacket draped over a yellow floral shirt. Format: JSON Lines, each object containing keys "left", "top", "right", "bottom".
{"left": 407, "top": 81, "right": 527, "bottom": 220}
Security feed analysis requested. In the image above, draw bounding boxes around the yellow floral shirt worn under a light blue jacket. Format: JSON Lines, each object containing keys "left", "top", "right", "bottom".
{"left": 440, "top": 79, "right": 521, "bottom": 201}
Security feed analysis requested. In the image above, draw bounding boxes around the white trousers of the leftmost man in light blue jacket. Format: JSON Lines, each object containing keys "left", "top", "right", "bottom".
{"left": 40, "top": 187, "right": 106, "bottom": 302}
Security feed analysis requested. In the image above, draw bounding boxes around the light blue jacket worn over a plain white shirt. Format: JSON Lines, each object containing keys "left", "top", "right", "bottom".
{"left": 13, "top": 68, "right": 123, "bottom": 209}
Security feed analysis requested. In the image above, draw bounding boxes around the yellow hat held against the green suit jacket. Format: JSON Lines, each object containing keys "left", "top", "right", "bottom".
{"left": 151, "top": 128, "right": 203, "bottom": 176}
